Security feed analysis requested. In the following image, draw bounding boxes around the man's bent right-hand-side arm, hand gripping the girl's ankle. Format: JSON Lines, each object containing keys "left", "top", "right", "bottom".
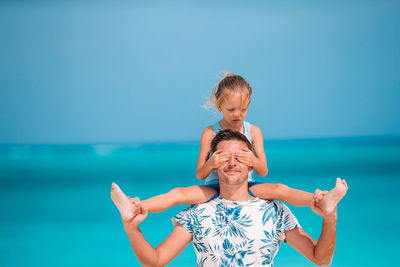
{"left": 285, "top": 190, "right": 337, "bottom": 266}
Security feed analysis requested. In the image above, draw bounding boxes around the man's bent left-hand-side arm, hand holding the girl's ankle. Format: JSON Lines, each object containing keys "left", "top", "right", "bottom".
{"left": 124, "top": 204, "right": 192, "bottom": 266}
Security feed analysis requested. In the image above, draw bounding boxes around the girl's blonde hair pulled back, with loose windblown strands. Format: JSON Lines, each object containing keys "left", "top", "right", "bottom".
{"left": 204, "top": 71, "right": 251, "bottom": 109}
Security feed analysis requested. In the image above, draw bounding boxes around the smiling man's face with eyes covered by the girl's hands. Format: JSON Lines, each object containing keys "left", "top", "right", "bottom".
{"left": 216, "top": 140, "right": 251, "bottom": 185}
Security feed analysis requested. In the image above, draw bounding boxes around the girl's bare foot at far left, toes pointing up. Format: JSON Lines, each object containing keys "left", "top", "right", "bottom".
{"left": 111, "top": 183, "right": 140, "bottom": 222}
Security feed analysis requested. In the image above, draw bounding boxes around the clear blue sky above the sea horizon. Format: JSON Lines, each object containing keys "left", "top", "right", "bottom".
{"left": 0, "top": 0, "right": 400, "bottom": 144}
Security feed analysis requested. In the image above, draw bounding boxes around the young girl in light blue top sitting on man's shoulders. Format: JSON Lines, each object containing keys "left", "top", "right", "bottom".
{"left": 142, "top": 73, "right": 347, "bottom": 214}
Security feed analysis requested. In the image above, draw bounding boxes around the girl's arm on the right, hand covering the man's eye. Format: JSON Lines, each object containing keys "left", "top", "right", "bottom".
{"left": 235, "top": 125, "right": 268, "bottom": 177}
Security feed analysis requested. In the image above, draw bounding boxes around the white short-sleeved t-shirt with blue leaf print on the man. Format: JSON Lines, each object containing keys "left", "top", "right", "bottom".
{"left": 172, "top": 196, "right": 300, "bottom": 266}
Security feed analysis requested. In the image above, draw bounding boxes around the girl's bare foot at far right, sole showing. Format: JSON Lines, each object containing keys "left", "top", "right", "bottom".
{"left": 317, "top": 178, "right": 347, "bottom": 215}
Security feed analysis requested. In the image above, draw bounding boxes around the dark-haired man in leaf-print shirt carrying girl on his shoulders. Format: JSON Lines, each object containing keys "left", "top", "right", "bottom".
{"left": 111, "top": 130, "right": 337, "bottom": 266}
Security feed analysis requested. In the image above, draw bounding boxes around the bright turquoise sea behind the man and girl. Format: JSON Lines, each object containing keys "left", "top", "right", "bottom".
{"left": 0, "top": 137, "right": 400, "bottom": 267}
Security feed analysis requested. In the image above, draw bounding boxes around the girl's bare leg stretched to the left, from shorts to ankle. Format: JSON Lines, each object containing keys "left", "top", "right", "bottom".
{"left": 142, "top": 185, "right": 217, "bottom": 212}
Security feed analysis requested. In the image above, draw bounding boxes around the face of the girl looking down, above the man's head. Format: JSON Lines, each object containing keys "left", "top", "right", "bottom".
{"left": 218, "top": 92, "right": 249, "bottom": 127}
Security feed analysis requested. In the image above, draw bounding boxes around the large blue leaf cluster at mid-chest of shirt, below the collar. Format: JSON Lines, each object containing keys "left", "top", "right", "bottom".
{"left": 212, "top": 203, "right": 252, "bottom": 239}
